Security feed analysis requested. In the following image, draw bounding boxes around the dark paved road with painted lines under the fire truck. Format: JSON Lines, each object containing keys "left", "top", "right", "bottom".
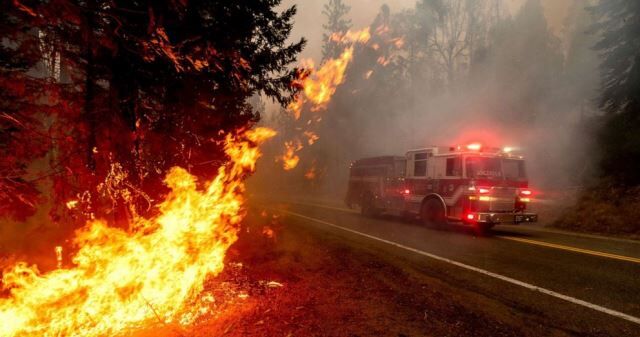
{"left": 262, "top": 203, "right": 640, "bottom": 336}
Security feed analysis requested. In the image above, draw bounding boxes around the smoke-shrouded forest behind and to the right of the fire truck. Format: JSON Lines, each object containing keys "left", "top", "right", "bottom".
{"left": 258, "top": 0, "right": 640, "bottom": 233}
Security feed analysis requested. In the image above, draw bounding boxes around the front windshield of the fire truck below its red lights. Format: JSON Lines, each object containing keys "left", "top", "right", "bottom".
{"left": 466, "top": 157, "right": 525, "bottom": 180}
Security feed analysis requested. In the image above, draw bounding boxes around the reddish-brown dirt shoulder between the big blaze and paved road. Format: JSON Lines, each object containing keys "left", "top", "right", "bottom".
{"left": 129, "top": 207, "right": 584, "bottom": 337}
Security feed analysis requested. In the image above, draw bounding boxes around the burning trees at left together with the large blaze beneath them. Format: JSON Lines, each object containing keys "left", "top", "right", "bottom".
{"left": 0, "top": 0, "right": 304, "bottom": 336}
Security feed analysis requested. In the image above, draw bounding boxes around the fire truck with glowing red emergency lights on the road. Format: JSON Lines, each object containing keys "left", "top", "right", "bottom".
{"left": 345, "top": 143, "right": 538, "bottom": 232}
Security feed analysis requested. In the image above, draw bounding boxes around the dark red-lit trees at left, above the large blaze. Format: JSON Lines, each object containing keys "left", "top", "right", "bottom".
{"left": 0, "top": 0, "right": 304, "bottom": 223}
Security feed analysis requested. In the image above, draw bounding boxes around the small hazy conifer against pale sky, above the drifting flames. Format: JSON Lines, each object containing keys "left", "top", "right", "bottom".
{"left": 322, "top": 0, "right": 351, "bottom": 61}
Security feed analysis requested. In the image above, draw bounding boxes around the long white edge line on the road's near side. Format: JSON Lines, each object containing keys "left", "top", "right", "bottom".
{"left": 280, "top": 210, "right": 640, "bottom": 324}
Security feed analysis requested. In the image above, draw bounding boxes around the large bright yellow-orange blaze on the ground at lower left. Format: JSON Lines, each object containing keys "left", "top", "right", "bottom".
{"left": 0, "top": 128, "right": 275, "bottom": 337}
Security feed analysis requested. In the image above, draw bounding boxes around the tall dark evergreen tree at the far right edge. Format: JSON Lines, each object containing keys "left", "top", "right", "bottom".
{"left": 592, "top": 0, "right": 640, "bottom": 186}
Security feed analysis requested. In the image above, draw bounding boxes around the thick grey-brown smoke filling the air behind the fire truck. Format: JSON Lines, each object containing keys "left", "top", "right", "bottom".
{"left": 251, "top": 0, "right": 599, "bottom": 211}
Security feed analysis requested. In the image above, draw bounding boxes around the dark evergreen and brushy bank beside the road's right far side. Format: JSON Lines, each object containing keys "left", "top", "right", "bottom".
{"left": 555, "top": 0, "right": 640, "bottom": 237}
